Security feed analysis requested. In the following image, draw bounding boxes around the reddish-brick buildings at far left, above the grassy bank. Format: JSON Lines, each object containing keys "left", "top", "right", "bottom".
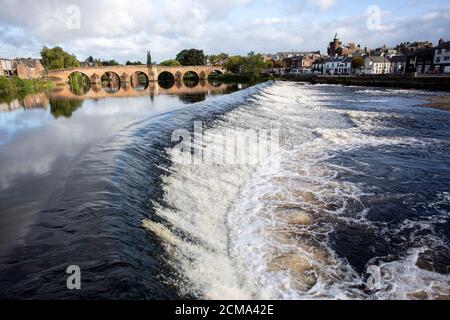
{"left": 0, "top": 58, "right": 45, "bottom": 79}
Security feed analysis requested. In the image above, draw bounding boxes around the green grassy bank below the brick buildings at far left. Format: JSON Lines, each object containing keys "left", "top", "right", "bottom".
{"left": 0, "top": 77, "right": 52, "bottom": 99}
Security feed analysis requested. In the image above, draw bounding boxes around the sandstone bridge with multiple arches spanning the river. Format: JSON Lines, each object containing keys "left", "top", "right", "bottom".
{"left": 47, "top": 66, "right": 225, "bottom": 84}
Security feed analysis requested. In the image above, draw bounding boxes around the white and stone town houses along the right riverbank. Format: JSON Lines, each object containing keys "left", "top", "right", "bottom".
{"left": 268, "top": 34, "right": 450, "bottom": 75}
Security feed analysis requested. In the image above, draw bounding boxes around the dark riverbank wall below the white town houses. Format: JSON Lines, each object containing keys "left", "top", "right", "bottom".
{"left": 280, "top": 75, "right": 450, "bottom": 91}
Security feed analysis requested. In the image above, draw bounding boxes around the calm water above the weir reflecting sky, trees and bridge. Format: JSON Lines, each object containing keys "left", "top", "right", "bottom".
{"left": 0, "top": 80, "right": 250, "bottom": 257}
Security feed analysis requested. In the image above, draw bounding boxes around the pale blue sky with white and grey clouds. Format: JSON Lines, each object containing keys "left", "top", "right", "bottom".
{"left": 0, "top": 0, "right": 450, "bottom": 62}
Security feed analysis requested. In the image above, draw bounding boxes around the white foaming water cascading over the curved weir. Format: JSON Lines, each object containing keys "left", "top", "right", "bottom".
{"left": 144, "top": 82, "right": 449, "bottom": 299}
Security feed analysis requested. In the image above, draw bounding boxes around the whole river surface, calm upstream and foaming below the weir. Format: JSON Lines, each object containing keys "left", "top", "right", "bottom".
{"left": 0, "top": 82, "right": 450, "bottom": 299}
